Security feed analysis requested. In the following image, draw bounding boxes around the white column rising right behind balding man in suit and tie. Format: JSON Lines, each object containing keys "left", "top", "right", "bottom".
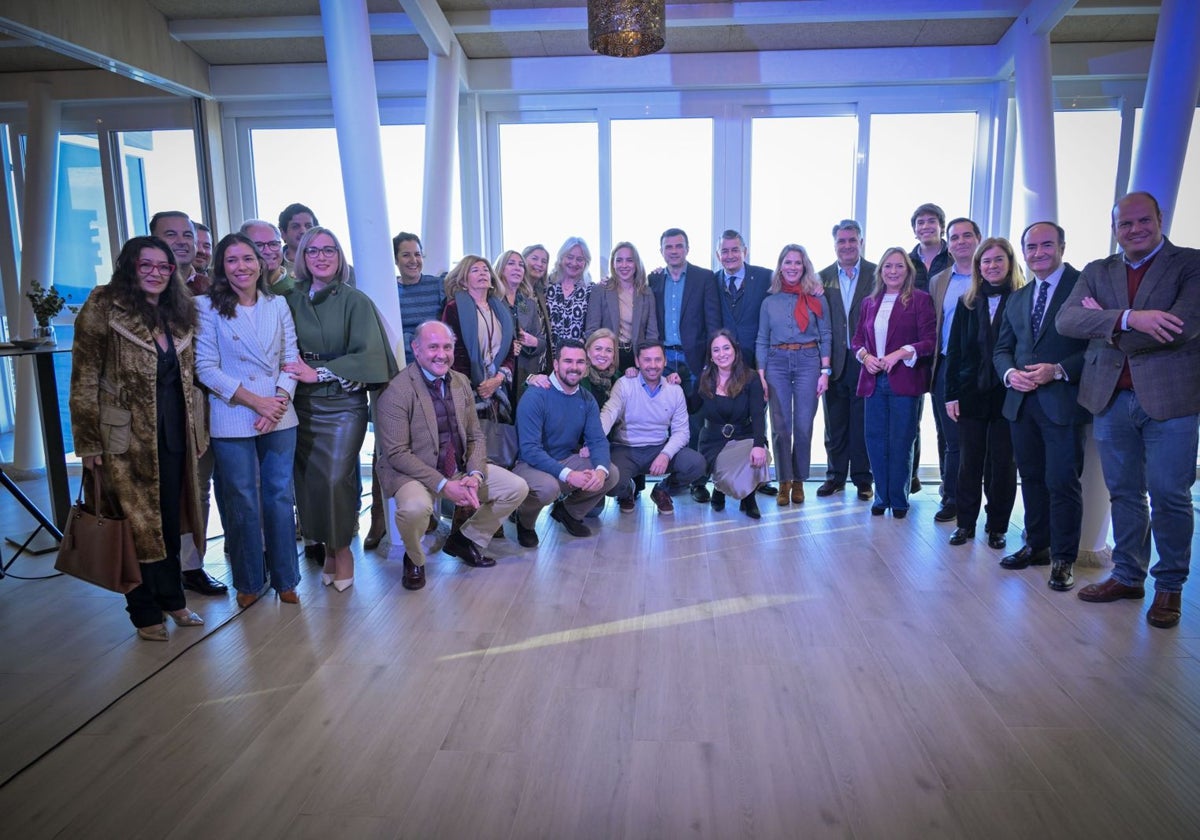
{"left": 1014, "top": 32, "right": 1058, "bottom": 226}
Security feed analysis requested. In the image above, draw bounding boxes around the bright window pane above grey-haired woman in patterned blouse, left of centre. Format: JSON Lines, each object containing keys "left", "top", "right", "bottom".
{"left": 499, "top": 122, "right": 600, "bottom": 265}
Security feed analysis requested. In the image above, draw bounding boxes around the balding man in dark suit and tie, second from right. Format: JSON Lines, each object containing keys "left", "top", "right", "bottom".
{"left": 994, "top": 222, "right": 1091, "bottom": 592}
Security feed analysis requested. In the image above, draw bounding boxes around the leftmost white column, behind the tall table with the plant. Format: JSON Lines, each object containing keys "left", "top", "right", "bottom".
{"left": 10, "top": 84, "right": 62, "bottom": 478}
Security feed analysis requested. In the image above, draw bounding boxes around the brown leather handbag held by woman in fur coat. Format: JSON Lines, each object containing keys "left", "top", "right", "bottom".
{"left": 54, "top": 469, "right": 142, "bottom": 595}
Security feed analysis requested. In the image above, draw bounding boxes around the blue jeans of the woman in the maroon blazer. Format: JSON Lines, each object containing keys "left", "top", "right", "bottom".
{"left": 863, "top": 373, "right": 921, "bottom": 511}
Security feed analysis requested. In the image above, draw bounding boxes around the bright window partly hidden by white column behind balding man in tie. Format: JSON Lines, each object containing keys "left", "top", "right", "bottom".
{"left": 1009, "top": 110, "right": 1121, "bottom": 269}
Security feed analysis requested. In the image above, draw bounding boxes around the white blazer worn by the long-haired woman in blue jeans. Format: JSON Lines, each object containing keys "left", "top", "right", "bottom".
{"left": 196, "top": 295, "right": 300, "bottom": 438}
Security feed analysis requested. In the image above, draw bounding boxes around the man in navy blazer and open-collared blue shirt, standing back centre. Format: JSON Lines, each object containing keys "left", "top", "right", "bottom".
{"left": 648, "top": 228, "right": 721, "bottom": 504}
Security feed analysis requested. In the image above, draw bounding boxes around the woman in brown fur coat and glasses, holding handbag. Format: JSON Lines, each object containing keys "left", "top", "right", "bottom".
{"left": 71, "top": 236, "right": 208, "bottom": 641}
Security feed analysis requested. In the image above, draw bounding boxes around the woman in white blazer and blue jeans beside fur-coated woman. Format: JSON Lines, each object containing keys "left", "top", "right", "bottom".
{"left": 196, "top": 233, "right": 300, "bottom": 608}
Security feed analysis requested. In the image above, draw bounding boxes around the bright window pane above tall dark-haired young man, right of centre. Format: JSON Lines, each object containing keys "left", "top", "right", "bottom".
{"left": 864, "top": 113, "right": 983, "bottom": 262}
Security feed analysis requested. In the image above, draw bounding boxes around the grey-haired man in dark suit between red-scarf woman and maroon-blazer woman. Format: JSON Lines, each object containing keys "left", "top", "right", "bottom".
{"left": 817, "top": 218, "right": 875, "bottom": 502}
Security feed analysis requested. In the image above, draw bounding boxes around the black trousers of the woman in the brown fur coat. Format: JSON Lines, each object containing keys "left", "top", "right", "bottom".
{"left": 125, "top": 440, "right": 187, "bottom": 628}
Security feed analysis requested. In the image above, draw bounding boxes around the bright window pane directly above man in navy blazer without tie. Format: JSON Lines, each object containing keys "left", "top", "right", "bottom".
{"left": 609, "top": 119, "right": 713, "bottom": 268}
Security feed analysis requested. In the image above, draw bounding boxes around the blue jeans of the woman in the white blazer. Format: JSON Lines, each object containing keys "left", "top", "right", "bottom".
{"left": 212, "top": 427, "right": 300, "bottom": 595}
